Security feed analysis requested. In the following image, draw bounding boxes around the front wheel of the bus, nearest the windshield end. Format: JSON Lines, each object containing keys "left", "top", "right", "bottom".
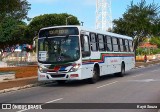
{"left": 89, "top": 67, "right": 99, "bottom": 84}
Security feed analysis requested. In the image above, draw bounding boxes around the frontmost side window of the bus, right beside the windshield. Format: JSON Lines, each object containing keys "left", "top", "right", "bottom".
{"left": 81, "top": 35, "right": 90, "bottom": 57}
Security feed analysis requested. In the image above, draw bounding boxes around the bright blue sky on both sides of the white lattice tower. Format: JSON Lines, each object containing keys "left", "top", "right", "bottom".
{"left": 27, "top": 0, "right": 160, "bottom": 28}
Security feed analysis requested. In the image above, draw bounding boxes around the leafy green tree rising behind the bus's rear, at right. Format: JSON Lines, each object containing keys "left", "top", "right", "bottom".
{"left": 113, "top": 0, "right": 160, "bottom": 49}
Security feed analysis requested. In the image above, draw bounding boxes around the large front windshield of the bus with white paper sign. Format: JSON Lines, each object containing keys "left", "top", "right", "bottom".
{"left": 38, "top": 36, "right": 80, "bottom": 63}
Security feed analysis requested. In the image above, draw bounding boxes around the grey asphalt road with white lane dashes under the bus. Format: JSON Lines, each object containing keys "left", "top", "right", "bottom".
{"left": 0, "top": 65, "right": 160, "bottom": 112}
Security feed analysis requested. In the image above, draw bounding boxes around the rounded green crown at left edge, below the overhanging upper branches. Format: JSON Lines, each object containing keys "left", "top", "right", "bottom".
{"left": 0, "top": 17, "right": 26, "bottom": 49}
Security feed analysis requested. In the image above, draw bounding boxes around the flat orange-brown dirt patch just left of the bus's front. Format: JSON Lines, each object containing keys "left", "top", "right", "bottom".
{"left": 0, "top": 66, "right": 38, "bottom": 78}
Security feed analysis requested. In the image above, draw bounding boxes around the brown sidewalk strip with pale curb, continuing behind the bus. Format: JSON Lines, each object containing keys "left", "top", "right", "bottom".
{"left": 0, "top": 60, "right": 160, "bottom": 94}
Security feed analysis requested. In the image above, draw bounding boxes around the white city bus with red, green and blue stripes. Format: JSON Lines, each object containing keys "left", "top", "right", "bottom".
{"left": 37, "top": 25, "right": 135, "bottom": 83}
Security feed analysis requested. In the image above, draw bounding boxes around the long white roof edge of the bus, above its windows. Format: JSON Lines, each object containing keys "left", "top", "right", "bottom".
{"left": 40, "top": 25, "right": 133, "bottom": 40}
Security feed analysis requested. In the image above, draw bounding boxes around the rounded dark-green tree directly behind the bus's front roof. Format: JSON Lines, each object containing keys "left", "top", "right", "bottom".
{"left": 28, "top": 13, "right": 80, "bottom": 39}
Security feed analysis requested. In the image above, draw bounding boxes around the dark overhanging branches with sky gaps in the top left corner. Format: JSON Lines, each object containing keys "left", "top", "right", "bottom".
{"left": 0, "top": 0, "right": 30, "bottom": 22}
